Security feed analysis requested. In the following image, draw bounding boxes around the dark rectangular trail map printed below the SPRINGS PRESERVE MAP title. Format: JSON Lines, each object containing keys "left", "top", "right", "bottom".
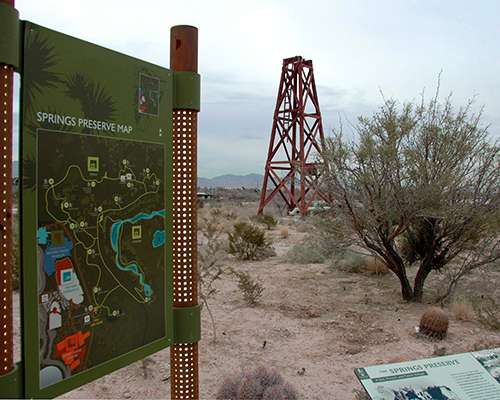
{"left": 37, "top": 130, "right": 166, "bottom": 388}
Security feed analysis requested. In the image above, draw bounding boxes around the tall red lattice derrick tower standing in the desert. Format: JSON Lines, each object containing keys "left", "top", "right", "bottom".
{"left": 259, "top": 56, "right": 324, "bottom": 216}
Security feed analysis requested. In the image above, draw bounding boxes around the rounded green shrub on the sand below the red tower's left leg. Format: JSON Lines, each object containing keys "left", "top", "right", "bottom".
{"left": 228, "top": 222, "right": 271, "bottom": 260}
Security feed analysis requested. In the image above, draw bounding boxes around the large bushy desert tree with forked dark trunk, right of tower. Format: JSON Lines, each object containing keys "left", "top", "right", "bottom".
{"left": 322, "top": 91, "right": 500, "bottom": 301}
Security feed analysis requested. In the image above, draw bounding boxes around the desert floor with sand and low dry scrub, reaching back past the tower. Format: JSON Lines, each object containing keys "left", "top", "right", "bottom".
{"left": 42, "top": 189, "right": 500, "bottom": 400}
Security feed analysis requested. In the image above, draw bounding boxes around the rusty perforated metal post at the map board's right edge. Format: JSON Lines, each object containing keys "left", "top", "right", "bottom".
{"left": 170, "top": 26, "right": 199, "bottom": 399}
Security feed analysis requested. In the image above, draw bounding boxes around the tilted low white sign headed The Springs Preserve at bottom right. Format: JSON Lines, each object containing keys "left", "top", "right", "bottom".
{"left": 355, "top": 348, "right": 500, "bottom": 400}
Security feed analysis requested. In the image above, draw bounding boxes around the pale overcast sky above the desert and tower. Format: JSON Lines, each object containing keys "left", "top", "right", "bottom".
{"left": 12, "top": 0, "right": 500, "bottom": 178}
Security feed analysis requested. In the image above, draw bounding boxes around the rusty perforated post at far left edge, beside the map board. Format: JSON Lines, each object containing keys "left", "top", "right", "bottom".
{"left": 0, "top": 0, "right": 14, "bottom": 375}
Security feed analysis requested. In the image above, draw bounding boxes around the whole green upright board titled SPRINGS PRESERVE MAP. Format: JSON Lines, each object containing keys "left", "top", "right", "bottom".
{"left": 22, "top": 22, "right": 173, "bottom": 398}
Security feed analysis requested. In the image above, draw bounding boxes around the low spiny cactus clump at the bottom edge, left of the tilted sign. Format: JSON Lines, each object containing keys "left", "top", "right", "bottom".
{"left": 216, "top": 367, "right": 299, "bottom": 400}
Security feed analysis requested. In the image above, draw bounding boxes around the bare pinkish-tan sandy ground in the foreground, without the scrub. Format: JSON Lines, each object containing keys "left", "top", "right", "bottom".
{"left": 12, "top": 230, "right": 500, "bottom": 400}
